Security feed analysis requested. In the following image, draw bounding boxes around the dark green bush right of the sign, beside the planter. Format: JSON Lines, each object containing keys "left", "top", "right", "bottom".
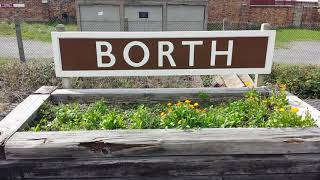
{"left": 265, "top": 64, "right": 320, "bottom": 99}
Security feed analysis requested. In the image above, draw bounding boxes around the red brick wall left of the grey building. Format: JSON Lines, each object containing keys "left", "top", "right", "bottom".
{"left": 0, "top": 0, "right": 76, "bottom": 21}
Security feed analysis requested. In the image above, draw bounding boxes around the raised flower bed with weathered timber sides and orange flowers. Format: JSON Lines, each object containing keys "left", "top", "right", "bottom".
{"left": 0, "top": 87, "right": 320, "bottom": 179}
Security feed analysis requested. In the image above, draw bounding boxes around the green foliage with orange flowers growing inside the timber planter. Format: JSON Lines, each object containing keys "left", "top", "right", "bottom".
{"left": 30, "top": 88, "right": 315, "bottom": 131}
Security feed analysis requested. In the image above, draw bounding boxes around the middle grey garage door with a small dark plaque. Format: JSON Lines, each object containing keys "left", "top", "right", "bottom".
{"left": 124, "top": 6, "right": 162, "bottom": 31}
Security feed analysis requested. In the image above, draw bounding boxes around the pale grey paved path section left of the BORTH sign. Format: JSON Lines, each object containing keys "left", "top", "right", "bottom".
{"left": 0, "top": 37, "right": 53, "bottom": 59}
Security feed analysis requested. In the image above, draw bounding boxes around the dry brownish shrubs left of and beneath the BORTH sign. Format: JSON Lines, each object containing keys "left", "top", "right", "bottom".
{"left": 0, "top": 59, "right": 192, "bottom": 102}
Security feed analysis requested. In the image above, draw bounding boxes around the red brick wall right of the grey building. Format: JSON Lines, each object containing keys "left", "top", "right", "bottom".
{"left": 208, "top": 0, "right": 320, "bottom": 27}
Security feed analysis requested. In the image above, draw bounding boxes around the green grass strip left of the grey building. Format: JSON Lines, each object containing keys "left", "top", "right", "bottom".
{"left": 0, "top": 22, "right": 77, "bottom": 42}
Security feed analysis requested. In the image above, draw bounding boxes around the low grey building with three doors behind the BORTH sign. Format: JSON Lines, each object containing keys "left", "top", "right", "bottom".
{"left": 76, "top": 0, "right": 208, "bottom": 31}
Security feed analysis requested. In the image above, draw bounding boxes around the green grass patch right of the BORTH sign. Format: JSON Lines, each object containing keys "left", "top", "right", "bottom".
{"left": 276, "top": 29, "right": 320, "bottom": 48}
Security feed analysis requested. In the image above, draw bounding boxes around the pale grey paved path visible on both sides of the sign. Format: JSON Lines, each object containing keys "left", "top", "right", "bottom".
{"left": 0, "top": 37, "right": 320, "bottom": 64}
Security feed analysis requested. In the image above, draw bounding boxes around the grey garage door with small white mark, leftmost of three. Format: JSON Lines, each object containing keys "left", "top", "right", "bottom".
{"left": 80, "top": 5, "right": 120, "bottom": 31}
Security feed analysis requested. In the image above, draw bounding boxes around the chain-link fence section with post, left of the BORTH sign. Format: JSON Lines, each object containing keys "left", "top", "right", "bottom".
{"left": 0, "top": 20, "right": 76, "bottom": 61}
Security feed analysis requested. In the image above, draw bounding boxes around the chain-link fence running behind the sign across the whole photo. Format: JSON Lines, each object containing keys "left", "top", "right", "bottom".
{"left": 0, "top": 21, "right": 320, "bottom": 64}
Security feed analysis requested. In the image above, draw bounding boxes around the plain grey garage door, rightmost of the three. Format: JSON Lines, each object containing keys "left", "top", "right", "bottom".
{"left": 167, "top": 5, "right": 205, "bottom": 31}
